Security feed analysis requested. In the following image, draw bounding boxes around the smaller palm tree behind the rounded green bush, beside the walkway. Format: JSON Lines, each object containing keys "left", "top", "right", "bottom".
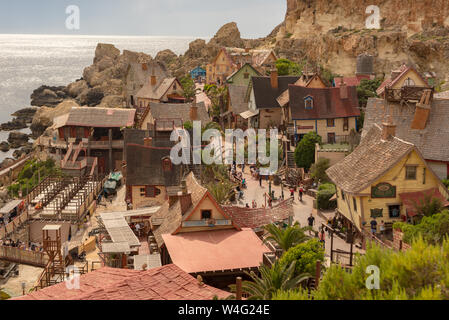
{"left": 265, "top": 223, "right": 310, "bottom": 252}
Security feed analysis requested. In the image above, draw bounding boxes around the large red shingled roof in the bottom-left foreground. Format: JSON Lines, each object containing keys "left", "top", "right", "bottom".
{"left": 13, "top": 264, "right": 230, "bottom": 300}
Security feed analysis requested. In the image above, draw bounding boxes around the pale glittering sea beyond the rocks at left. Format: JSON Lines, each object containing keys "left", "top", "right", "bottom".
{"left": 0, "top": 34, "right": 203, "bottom": 161}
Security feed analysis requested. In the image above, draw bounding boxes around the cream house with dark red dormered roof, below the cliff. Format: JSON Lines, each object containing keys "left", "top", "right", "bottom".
{"left": 284, "top": 83, "right": 360, "bottom": 144}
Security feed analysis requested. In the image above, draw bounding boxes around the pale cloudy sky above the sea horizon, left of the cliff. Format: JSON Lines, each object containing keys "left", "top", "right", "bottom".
{"left": 0, "top": 0, "right": 287, "bottom": 38}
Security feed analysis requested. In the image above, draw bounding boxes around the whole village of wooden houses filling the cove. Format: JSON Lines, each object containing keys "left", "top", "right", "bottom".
{"left": 0, "top": 11, "right": 449, "bottom": 300}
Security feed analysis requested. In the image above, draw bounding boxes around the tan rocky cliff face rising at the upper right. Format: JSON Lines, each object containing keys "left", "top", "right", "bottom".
{"left": 273, "top": 0, "right": 449, "bottom": 86}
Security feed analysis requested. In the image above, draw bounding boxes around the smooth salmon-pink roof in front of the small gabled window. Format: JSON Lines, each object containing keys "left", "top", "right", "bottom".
{"left": 162, "top": 229, "right": 270, "bottom": 273}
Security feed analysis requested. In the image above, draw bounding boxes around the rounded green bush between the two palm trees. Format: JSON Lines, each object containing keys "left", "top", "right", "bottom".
{"left": 279, "top": 239, "right": 324, "bottom": 276}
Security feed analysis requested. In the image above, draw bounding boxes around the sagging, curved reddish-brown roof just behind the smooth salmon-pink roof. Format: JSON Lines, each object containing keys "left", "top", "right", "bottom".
{"left": 223, "top": 199, "right": 293, "bottom": 229}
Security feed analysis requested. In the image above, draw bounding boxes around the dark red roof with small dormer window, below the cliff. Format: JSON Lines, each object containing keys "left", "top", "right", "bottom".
{"left": 288, "top": 85, "right": 360, "bottom": 120}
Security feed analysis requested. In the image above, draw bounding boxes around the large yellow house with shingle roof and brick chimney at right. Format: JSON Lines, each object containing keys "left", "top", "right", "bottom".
{"left": 327, "top": 121, "right": 449, "bottom": 231}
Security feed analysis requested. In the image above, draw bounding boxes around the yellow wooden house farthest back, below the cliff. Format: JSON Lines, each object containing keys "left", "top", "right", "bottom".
{"left": 206, "top": 48, "right": 277, "bottom": 85}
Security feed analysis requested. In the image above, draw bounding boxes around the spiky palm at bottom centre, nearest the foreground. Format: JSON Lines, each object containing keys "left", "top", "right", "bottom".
{"left": 230, "top": 261, "right": 310, "bottom": 300}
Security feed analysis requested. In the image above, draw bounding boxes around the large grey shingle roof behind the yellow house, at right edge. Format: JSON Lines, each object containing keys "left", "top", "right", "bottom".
{"left": 362, "top": 98, "right": 449, "bottom": 161}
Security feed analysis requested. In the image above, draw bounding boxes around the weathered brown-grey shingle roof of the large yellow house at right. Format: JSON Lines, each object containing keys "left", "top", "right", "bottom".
{"left": 326, "top": 124, "right": 415, "bottom": 193}
